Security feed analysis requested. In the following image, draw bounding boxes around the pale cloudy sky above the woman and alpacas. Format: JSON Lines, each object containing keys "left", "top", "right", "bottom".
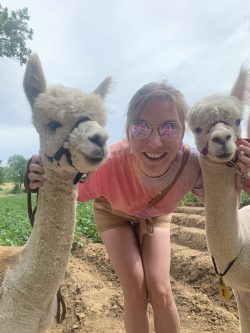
{"left": 0, "top": 0, "right": 250, "bottom": 165}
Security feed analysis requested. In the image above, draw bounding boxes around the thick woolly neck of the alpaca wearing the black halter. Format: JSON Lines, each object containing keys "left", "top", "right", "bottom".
{"left": 3, "top": 170, "right": 76, "bottom": 308}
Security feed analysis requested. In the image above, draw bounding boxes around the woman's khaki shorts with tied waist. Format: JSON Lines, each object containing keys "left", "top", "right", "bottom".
{"left": 93, "top": 197, "right": 172, "bottom": 244}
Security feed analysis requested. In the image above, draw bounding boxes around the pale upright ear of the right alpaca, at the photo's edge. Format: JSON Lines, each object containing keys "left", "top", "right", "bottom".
{"left": 230, "top": 63, "right": 250, "bottom": 102}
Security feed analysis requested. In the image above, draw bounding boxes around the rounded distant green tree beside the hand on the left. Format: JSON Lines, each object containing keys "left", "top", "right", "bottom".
{"left": 8, "top": 155, "right": 27, "bottom": 189}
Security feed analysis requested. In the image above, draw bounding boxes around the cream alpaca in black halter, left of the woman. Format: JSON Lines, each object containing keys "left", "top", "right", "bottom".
{"left": 0, "top": 54, "right": 111, "bottom": 333}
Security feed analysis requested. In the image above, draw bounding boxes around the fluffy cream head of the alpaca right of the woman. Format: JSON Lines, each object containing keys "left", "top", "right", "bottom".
{"left": 188, "top": 63, "right": 249, "bottom": 163}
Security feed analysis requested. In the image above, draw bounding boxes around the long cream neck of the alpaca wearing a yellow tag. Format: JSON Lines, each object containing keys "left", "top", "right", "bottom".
{"left": 200, "top": 157, "right": 242, "bottom": 272}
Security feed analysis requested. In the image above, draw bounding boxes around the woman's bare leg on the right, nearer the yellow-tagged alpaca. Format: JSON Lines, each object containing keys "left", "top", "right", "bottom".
{"left": 142, "top": 227, "right": 180, "bottom": 333}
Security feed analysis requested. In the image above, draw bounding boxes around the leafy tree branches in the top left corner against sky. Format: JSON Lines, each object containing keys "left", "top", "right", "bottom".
{"left": 0, "top": 4, "right": 33, "bottom": 65}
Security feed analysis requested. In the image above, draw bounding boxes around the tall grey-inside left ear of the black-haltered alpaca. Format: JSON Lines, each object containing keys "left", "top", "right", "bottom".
{"left": 23, "top": 53, "right": 46, "bottom": 107}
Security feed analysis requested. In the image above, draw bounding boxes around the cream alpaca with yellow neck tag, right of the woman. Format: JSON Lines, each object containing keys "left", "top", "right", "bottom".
{"left": 188, "top": 66, "right": 250, "bottom": 333}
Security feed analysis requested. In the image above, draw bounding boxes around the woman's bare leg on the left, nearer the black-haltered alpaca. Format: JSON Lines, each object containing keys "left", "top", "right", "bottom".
{"left": 101, "top": 225, "right": 149, "bottom": 333}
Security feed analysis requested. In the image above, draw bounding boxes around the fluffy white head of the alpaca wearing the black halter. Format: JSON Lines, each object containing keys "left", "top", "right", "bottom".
{"left": 24, "top": 54, "right": 111, "bottom": 172}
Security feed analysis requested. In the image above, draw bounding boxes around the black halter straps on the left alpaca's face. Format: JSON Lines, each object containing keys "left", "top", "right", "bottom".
{"left": 45, "top": 116, "right": 92, "bottom": 184}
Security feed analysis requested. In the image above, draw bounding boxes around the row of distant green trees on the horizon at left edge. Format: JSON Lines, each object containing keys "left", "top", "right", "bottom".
{"left": 0, "top": 155, "right": 28, "bottom": 191}
